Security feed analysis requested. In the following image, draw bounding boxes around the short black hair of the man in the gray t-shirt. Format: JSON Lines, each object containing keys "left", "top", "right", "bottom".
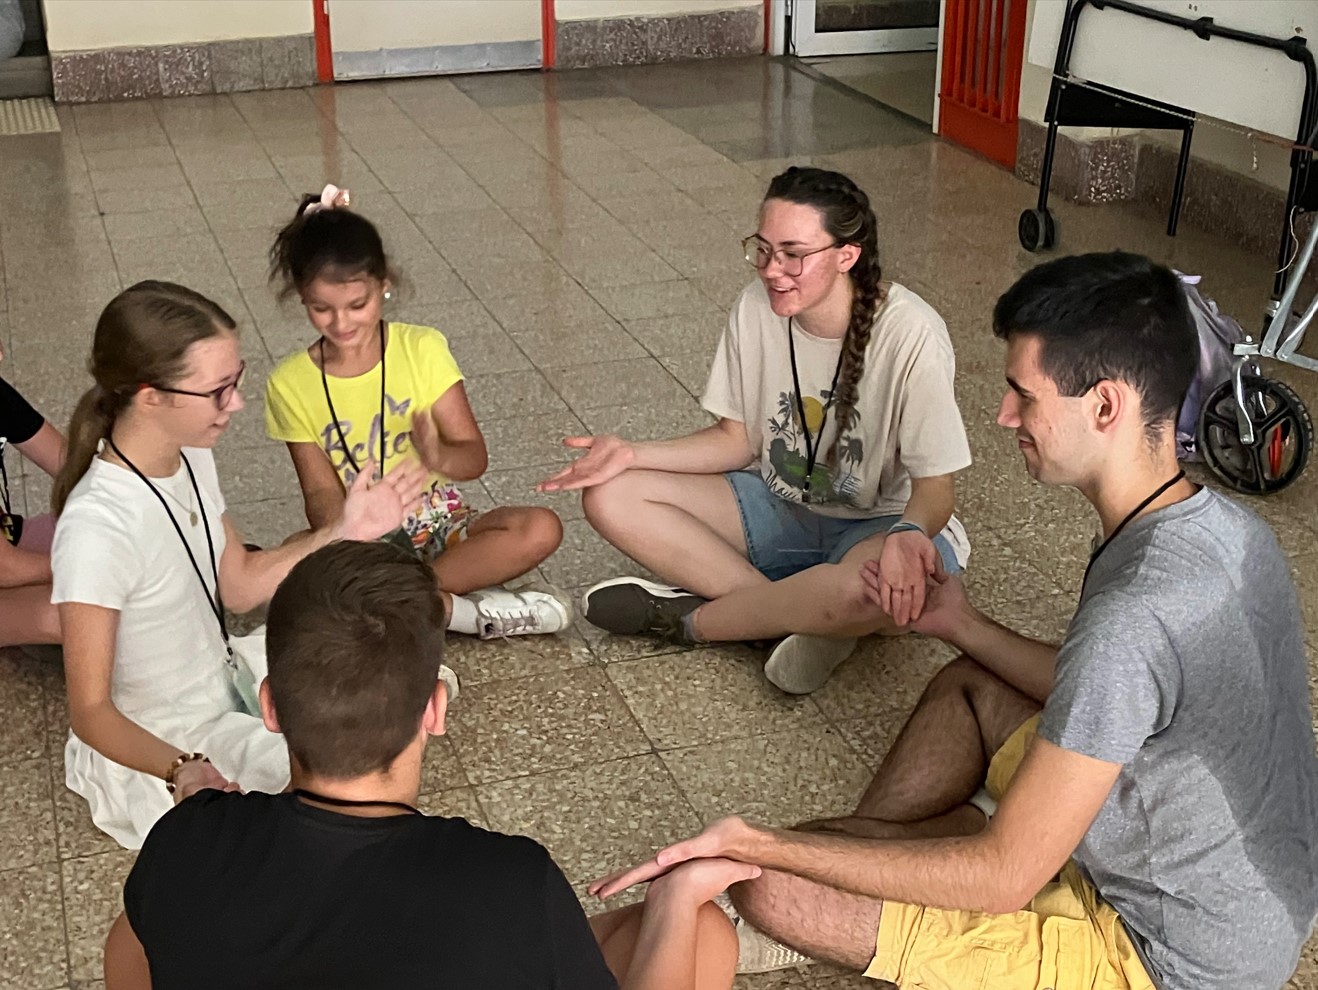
{"left": 992, "top": 250, "right": 1199, "bottom": 434}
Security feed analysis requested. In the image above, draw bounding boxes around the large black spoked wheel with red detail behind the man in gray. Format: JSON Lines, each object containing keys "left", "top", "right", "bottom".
{"left": 1199, "top": 374, "right": 1314, "bottom": 494}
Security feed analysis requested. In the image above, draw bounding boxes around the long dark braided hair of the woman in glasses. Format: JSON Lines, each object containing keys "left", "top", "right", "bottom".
{"left": 764, "top": 165, "right": 886, "bottom": 467}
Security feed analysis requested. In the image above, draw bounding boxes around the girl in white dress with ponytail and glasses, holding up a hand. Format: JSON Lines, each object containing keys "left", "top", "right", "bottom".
{"left": 51, "top": 282, "right": 423, "bottom": 849}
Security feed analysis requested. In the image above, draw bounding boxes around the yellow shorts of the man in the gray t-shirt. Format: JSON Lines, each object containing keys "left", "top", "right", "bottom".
{"left": 865, "top": 716, "right": 1153, "bottom": 990}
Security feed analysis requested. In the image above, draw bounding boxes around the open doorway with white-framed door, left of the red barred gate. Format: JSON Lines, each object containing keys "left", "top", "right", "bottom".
{"left": 787, "top": 0, "right": 940, "bottom": 127}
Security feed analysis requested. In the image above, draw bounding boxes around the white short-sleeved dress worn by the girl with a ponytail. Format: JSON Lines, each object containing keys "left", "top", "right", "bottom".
{"left": 51, "top": 450, "right": 289, "bottom": 849}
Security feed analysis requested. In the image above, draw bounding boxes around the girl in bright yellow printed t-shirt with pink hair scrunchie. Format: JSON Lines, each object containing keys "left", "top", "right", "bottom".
{"left": 265, "top": 186, "right": 571, "bottom": 638}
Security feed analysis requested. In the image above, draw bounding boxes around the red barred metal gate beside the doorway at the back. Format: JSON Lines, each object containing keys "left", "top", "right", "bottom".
{"left": 938, "top": 0, "right": 1025, "bottom": 169}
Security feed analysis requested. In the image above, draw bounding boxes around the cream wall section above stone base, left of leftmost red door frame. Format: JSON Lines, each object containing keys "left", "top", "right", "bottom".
{"left": 43, "top": 0, "right": 312, "bottom": 51}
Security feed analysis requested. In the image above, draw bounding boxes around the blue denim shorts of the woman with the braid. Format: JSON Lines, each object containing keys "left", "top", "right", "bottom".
{"left": 724, "top": 471, "right": 961, "bottom": 581}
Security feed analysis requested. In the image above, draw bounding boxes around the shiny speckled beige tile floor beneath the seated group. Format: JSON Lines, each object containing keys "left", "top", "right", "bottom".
{"left": 0, "top": 59, "right": 1318, "bottom": 990}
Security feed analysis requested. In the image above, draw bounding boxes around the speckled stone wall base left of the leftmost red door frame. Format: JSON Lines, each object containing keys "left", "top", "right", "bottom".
{"left": 50, "top": 34, "right": 316, "bottom": 103}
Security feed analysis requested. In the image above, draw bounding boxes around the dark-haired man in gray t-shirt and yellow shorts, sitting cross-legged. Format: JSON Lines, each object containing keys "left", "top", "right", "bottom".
{"left": 600, "top": 252, "right": 1318, "bottom": 990}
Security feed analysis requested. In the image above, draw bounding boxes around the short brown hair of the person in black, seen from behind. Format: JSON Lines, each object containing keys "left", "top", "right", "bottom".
{"left": 265, "top": 542, "right": 445, "bottom": 779}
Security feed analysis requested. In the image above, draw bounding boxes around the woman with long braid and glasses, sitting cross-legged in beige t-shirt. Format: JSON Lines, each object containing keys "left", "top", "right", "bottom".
{"left": 542, "top": 167, "right": 970, "bottom": 693}
